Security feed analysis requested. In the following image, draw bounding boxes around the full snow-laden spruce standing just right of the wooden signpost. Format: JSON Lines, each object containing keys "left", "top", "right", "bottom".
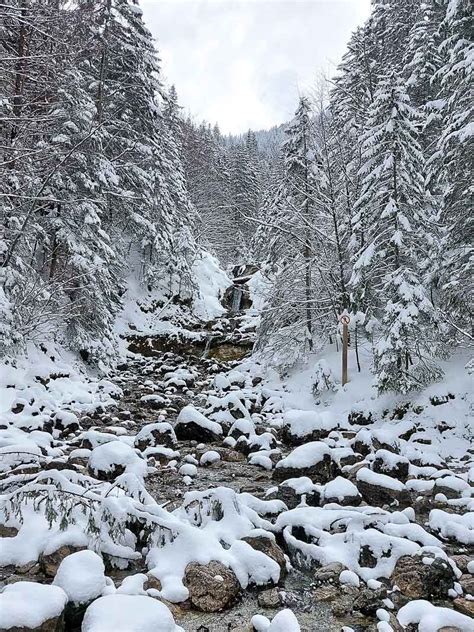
{"left": 352, "top": 75, "right": 440, "bottom": 393}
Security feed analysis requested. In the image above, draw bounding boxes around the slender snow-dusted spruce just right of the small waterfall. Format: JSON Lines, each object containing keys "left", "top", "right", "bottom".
{"left": 257, "top": 97, "right": 325, "bottom": 364}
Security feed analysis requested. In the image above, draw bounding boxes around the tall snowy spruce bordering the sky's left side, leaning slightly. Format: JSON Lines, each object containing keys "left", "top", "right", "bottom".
{"left": 85, "top": 0, "right": 191, "bottom": 297}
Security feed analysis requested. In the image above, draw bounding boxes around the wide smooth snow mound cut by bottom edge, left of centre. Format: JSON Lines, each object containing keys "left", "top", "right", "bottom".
{"left": 81, "top": 594, "right": 182, "bottom": 632}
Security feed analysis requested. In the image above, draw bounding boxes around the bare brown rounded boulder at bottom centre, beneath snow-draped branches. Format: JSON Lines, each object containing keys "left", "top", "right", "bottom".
{"left": 184, "top": 562, "right": 240, "bottom": 612}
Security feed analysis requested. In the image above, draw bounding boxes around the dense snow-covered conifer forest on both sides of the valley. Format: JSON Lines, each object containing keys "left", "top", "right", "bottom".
{"left": 0, "top": 0, "right": 473, "bottom": 391}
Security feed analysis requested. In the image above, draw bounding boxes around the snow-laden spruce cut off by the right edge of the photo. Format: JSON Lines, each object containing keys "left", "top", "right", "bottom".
{"left": 433, "top": 0, "right": 474, "bottom": 336}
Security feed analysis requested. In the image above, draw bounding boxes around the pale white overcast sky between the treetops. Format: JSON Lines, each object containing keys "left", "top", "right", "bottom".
{"left": 141, "top": 0, "right": 370, "bottom": 133}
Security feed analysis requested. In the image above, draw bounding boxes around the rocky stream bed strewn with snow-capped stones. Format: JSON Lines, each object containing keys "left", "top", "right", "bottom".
{"left": 0, "top": 312, "right": 474, "bottom": 632}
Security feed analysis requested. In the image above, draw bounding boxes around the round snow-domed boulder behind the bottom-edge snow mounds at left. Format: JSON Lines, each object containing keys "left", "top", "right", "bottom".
{"left": 53, "top": 550, "right": 106, "bottom": 604}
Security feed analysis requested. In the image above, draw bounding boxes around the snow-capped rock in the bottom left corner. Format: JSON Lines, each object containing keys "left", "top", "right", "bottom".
{"left": 0, "top": 582, "right": 67, "bottom": 632}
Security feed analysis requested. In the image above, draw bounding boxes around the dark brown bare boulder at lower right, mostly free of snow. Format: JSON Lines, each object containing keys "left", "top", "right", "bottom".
{"left": 392, "top": 555, "right": 456, "bottom": 600}
